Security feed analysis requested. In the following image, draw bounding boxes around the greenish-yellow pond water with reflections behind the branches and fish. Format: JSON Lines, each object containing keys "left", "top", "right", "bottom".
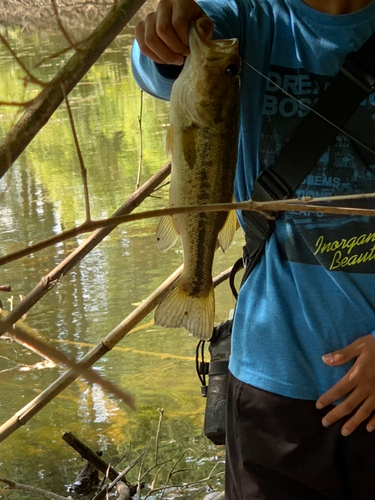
{"left": 0, "top": 4, "right": 243, "bottom": 500}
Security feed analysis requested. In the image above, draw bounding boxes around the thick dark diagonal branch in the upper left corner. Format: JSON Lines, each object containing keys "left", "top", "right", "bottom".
{"left": 0, "top": 0, "right": 145, "bottom": 178}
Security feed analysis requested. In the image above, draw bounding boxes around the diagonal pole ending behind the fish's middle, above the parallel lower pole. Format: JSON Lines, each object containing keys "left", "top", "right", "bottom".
{"left": 0, "top": 162, "right": 171, "bottom": 336}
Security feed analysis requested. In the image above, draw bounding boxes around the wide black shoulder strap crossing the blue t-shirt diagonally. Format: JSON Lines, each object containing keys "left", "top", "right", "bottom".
{"left": 231, "top": 33, "right": 375, "bottom": 296}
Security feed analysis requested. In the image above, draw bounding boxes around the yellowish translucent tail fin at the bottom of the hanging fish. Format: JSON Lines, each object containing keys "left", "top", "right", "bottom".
{"left": 155, "top": 281, "right": 215, "bottom": 340}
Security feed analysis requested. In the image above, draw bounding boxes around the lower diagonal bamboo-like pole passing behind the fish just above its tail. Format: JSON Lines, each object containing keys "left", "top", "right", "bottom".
{"left": 0, "top": 266, "right": 231, "bottom": 443}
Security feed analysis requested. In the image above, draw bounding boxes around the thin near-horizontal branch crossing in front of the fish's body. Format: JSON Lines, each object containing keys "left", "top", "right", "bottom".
{"left": 0, "top": 193, "right": 375, "bottom": 266}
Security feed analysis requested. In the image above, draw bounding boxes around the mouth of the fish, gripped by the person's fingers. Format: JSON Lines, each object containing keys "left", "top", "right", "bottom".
{"left": 189, "top": 23, "right": 238, "bottom": 62}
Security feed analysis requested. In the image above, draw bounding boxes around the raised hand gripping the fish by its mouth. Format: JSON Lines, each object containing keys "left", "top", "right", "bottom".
{"left": 135, "top": 0, "right": 214, "bottom": 65}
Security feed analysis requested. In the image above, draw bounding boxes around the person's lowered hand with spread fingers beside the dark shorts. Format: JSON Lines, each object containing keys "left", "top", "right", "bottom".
{"left": 316, "top": 334, "right": 375, "bottom": 436}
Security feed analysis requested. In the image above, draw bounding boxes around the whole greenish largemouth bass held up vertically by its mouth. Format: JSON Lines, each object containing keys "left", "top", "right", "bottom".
{"left": 154, "top": 23, "right": 241, "bottom": 340}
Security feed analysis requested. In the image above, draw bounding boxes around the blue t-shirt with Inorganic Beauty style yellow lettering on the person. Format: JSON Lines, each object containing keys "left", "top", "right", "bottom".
{"left": 132, "top": 0, "right": 375, "bottom": 399}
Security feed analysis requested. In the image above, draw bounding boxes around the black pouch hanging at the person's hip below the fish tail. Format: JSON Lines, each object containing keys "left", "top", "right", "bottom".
{"left": 197, "top": 320, "right": 233, "bottom": 444}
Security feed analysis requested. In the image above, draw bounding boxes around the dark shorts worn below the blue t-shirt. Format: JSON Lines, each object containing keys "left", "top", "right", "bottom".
{"left": 225, "top": 375, "right": 375, "bottom": 500}
